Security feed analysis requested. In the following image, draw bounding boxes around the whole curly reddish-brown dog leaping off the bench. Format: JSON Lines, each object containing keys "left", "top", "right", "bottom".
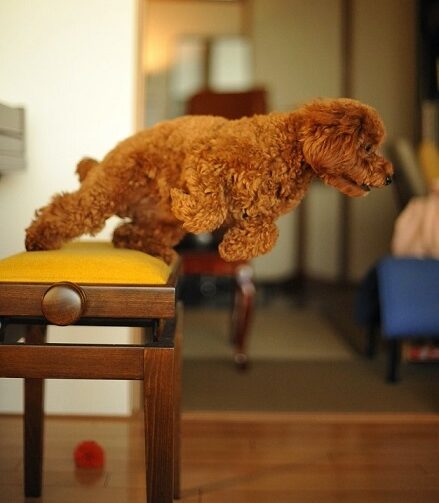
{"left": 26, "top": 99, "right": 393, "bottom": 262}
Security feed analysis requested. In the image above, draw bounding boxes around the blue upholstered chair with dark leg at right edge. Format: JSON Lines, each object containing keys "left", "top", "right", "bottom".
{"left": 376, "top": 257, "right": 439, "bottom": 382}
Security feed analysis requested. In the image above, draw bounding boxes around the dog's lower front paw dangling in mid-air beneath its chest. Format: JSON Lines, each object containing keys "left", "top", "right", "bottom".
{"left": 218, "top": 217, "right": 279, "bottom": 262}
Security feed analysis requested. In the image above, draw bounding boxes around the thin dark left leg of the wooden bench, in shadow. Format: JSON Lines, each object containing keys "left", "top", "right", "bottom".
{"left": 24, "top": 326, "right": 46, "bottom": 498}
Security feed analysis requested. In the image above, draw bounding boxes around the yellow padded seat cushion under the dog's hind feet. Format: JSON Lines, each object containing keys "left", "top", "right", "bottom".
{"left": 0, "top": 241, "right": 170, "bottom": 285}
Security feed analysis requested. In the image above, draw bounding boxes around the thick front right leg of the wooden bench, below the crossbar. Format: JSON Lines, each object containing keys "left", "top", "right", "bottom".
{"left": 143, "top": 347, "right": 175, "bottom": 503}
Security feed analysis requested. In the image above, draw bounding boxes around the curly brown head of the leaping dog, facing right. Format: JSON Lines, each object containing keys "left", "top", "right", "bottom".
{"left": 300, "top": 98, "right": 393, "bottom": 197}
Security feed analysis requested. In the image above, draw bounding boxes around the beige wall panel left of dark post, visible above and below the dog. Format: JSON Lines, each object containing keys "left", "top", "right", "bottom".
{"left": 248, "top": 0, "right": 342, "bottom": 281}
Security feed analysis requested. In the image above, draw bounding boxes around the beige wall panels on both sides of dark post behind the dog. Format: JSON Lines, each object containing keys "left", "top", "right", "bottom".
{"left": 248, "top": 0, "right": 416, "bottom": 280}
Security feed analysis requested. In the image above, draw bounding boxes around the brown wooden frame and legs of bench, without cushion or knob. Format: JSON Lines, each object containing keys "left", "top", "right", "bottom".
{"left": 0, "top": 265, "right": 181, "bottom": 503}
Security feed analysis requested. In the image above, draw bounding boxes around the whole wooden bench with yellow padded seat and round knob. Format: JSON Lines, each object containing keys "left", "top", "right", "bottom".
{"left": 0, "top": 242, "right": 181, "bottom": 503}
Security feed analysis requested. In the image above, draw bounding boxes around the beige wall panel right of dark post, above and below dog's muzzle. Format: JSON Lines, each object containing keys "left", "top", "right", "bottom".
{"left": 349, "top": 0, "right": 416, "bottom": 279}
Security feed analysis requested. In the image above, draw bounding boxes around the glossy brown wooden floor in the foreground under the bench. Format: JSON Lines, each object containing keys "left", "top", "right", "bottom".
{"left": 0, "top": 413, "right": 439, "bottom": 503}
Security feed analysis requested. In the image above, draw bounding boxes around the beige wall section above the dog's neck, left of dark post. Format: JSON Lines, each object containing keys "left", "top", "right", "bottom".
{"left": 249, "top": 0, "right": 341, "bottom": 111}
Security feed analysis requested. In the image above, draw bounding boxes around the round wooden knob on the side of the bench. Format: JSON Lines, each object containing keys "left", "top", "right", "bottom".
{"left": 41, "top": 283, "right": 86, "bottom": 326}
